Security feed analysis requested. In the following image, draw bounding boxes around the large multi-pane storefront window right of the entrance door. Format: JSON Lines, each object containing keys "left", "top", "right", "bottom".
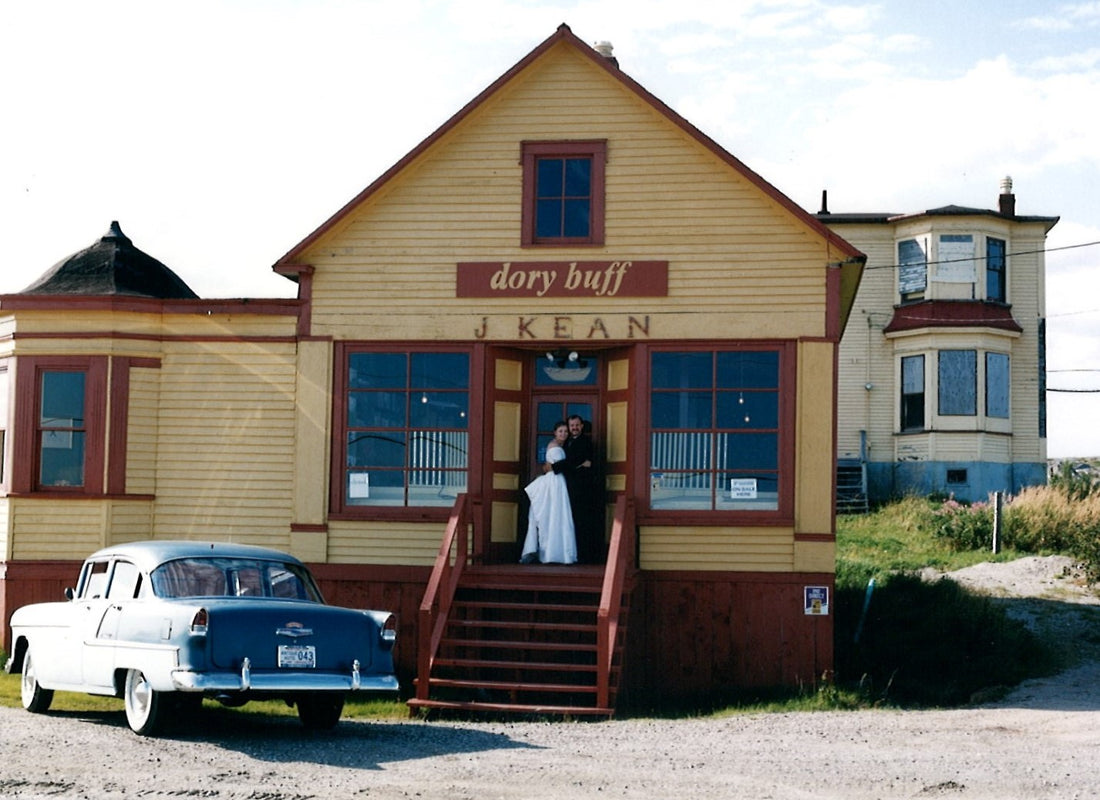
{"left": 649, "top": 350, "right": 790, "bottom": 512}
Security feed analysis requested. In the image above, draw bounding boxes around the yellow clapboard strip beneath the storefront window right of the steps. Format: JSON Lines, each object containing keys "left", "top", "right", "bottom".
{"left": 638, "top": 526, "right": 794, "bottom": 572}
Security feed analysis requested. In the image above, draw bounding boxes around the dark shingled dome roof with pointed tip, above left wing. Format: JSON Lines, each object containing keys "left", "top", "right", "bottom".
{"left": 19, "top": 222, "right": 198, "bottom": 300}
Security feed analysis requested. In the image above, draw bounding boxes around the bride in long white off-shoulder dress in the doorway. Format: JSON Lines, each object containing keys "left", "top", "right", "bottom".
{"left": 519, "top": 423, "right": 576, "bottom": 563}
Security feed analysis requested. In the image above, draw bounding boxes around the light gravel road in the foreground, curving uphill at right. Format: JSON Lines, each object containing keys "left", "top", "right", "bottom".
{"left": 0, "top": 559, "right": 1100, "bottom": 800}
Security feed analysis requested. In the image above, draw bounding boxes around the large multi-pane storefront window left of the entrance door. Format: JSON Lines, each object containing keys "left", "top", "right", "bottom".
{"left": 333, "top": 350, "right": 470, "bottom": 511}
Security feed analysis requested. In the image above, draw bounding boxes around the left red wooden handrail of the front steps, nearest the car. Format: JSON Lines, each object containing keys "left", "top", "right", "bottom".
{"left": 416, "top": 494, "right": 473, "bottom": 700}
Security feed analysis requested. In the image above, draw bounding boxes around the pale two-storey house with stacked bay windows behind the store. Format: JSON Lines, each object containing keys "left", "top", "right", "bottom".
{"left": 817, "top": 178, "right": 1058, "bottom": 511}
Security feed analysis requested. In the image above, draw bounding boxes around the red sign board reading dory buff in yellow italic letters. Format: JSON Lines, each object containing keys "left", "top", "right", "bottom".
{"left": 455, "top": 261, "right": 669, "bottom": 298}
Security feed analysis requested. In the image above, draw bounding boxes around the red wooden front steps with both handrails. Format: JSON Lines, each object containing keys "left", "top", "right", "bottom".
{"left": 408, "top": 495, "right": 637, "bottom": 716}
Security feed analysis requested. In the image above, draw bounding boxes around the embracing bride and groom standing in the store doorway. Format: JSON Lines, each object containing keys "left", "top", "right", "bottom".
{"left": 520, "top": 414, "right": 603, "bottom": 563}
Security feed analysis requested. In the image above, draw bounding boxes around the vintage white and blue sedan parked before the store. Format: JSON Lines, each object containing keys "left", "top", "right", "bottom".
{"left": 8, "top": 541, "right": 398, "bottom": 735}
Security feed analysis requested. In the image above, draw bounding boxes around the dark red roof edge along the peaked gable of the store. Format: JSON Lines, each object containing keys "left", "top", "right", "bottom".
{"left": 274, "top": 23, "right": 866, "bottom": 271}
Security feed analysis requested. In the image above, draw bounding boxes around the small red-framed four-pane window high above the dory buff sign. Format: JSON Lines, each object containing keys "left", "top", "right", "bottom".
{"left": 520, "top": 140, "right": 607, "bottom": 246}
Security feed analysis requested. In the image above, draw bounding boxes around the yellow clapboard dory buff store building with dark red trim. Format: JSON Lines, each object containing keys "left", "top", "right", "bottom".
{"left": 0, "top": 25, "right": 864, "bottom": 713}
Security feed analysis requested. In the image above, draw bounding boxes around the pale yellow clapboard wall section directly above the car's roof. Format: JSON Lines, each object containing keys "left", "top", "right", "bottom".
{"left": 155, "top": 341, "right": 296, "bottom": 546}
